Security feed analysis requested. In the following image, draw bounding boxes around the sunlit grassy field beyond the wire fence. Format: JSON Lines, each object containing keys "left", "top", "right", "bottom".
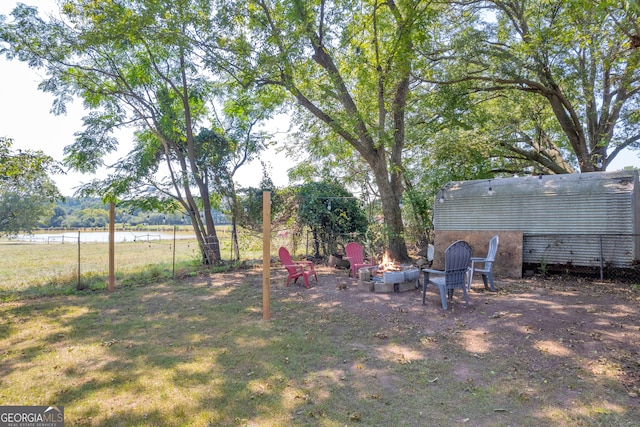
{"left": 0, "top": 226, "right": 290, "bottom": 300}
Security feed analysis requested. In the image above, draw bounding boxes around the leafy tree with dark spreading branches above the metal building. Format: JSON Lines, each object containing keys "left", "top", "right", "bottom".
{"left": 427, "top": 0, "right": 640, "bottom": 173}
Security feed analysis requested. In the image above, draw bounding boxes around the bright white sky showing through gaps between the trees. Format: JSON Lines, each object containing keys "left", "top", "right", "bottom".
{"left": 0, "top": 0, "right": 640, "bottom": 196}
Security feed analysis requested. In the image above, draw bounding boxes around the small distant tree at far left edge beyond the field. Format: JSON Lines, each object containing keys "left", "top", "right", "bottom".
{"left": 0, "top": 137, "right": 61, "bottom": 235}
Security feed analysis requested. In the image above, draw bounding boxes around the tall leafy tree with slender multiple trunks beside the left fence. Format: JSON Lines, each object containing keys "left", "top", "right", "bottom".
{"left": 0, "top": 0, "right": 268, "bottom": 264}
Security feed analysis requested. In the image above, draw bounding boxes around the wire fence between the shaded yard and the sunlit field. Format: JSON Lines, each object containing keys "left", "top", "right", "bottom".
{"left": 0, "top": 226, "right": 322, "bottom": 291}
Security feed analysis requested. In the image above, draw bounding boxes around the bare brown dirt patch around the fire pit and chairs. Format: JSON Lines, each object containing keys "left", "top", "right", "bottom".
{"left": 264, "top": 267, "right": 640, "bottom": 423}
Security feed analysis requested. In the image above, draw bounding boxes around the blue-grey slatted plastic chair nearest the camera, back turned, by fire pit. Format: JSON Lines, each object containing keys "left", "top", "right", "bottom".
{"left": 422, "top": 240, "right": 471, "bottom": 310}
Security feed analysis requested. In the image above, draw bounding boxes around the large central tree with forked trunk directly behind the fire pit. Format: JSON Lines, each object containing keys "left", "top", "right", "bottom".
{"left": 208, "top": 0, "right": 432, "bottom": 261}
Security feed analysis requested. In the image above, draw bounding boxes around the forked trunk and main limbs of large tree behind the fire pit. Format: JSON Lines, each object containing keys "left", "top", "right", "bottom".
{"left": 252, "top": 0, "right": 418, "bottom": 261}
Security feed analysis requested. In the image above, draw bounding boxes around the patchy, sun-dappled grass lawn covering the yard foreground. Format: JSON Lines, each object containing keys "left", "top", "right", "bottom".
{"left": 0, "top": 268, "right": 640, "bottom": 427}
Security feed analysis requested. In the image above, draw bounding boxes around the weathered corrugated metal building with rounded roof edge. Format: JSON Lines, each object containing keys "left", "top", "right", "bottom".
{"left": 434, "top": 171, "right": 640, "bottom": 267}
